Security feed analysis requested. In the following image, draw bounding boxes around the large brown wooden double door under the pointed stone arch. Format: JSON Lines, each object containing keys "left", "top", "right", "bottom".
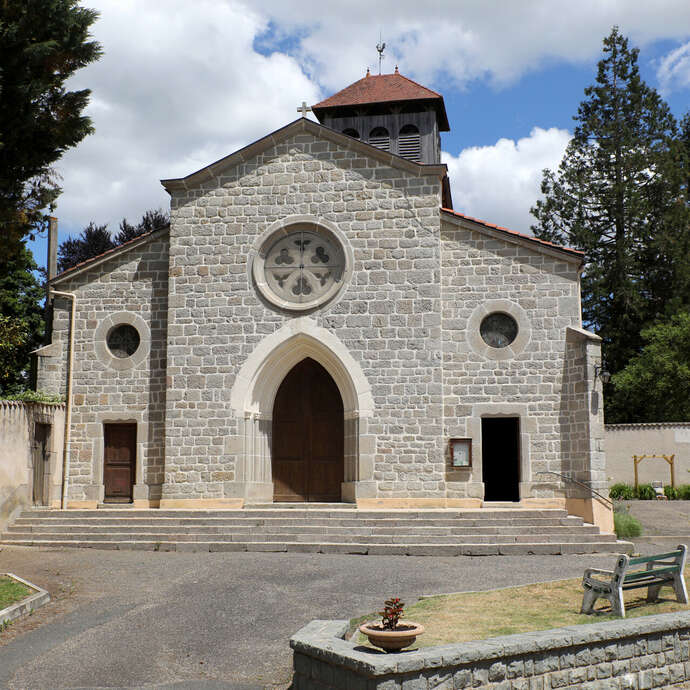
{"left": 271, "top": 357, "right": 345, "bottom": 502}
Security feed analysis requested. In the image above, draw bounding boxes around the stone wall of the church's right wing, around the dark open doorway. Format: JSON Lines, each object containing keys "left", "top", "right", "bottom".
{"left": 441, "top": 217, "right": 582, "bottom": 498}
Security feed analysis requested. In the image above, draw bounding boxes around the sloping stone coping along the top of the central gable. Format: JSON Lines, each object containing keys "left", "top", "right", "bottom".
{"left": 161, "top": 117, "right": 448, "bottom": 194}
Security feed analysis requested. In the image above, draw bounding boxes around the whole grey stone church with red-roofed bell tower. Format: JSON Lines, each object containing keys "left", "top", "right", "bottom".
{"left": 36, "top": 68, "right": 611, "bottom": 531}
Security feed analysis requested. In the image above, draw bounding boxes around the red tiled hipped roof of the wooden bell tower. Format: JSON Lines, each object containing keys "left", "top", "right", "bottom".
{"left": 312, "top": 67, "right": 450, "bottom": 132}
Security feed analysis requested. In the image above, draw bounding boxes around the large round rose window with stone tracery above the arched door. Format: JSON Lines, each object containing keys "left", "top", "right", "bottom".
{"left": 253, "top": 226, "right": 346, "bottom": 311}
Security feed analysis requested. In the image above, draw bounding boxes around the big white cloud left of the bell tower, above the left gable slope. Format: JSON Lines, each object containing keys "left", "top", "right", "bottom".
{"left": 57, "top": 0, "right": 319, "bottom": 231}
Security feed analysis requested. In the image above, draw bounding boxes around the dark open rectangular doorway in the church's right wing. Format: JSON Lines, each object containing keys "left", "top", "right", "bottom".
{"left": 482, "top": 417, "right": 520, "bottom": 501}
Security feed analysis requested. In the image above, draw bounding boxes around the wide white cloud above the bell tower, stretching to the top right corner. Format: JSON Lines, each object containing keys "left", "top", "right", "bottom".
{"left": 252, "top": 0, "right": 690, "bottom": 89}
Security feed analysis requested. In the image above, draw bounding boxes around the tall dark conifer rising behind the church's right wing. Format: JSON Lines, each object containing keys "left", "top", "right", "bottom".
{"left": 532, "top": 27, "right": 690, "bottom": 421}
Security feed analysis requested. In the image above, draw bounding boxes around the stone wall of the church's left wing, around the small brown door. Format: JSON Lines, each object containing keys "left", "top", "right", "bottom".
{"left": 38, "top": 231, "right": 168, "bottom": 501}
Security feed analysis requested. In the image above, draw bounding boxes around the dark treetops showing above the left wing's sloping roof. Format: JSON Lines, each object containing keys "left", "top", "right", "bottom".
{"left": 58, "top": 209, "right": 170, "bottom": 272}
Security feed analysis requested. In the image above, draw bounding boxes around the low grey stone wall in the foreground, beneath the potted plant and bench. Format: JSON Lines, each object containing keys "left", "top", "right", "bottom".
{"left": 290, "top": 612, "right": 690, "bottom": 690}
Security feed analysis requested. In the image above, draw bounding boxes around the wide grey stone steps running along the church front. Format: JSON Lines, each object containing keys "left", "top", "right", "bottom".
{"left": 0, "top": 503, "right": 632, "bottom": 556}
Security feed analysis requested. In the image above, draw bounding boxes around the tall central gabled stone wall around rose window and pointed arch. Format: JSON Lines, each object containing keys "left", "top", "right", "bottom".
{"left": 164, "top": 131, "right": 444, "bottom": 499}
